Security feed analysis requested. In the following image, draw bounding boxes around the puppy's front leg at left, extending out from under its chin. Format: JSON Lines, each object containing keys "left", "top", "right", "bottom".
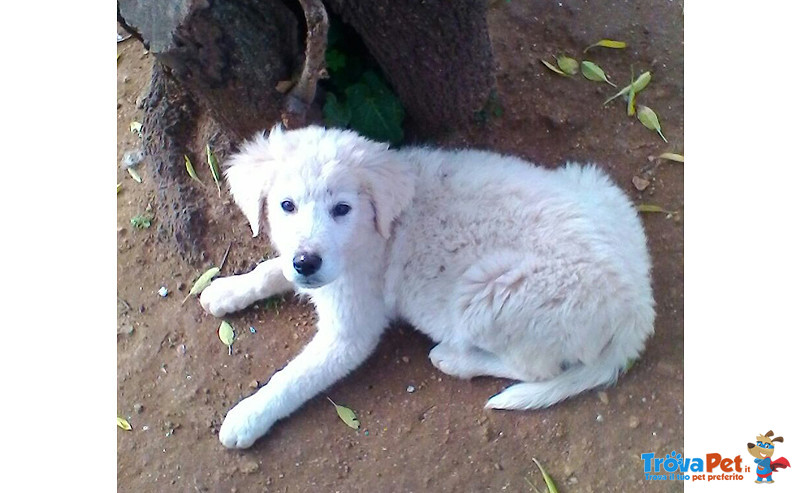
{"left": 200, "top": 257, "right": 294, "bottom": 317}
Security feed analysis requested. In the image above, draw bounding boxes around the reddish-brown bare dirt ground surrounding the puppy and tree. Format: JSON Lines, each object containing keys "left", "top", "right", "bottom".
{"left": 117, "top": 0, "right": 683, "bottom": 492}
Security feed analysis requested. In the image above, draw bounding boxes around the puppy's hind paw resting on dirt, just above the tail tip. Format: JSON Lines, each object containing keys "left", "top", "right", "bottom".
{"left": 428, "top": 343, "right": 524, "bottom": 380}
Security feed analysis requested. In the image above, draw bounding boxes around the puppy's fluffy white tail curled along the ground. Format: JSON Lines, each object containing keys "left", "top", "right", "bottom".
{"left": 486, "top": 309, "right": 654, "bottom": 409}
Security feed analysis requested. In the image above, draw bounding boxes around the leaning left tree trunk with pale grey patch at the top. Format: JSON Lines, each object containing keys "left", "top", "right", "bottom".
{"left": 117, "top": 0, "right": 302, "bottom": 138}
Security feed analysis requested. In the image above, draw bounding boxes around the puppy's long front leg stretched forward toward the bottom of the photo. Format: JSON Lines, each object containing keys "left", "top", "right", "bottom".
{"left": 219, "top": 325, "right": 382, "bottom": 448}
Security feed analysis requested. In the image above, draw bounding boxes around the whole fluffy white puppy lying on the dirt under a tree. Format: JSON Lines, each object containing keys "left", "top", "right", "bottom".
{"left": 200, "top": 127, "right": 655, "bottom": 448}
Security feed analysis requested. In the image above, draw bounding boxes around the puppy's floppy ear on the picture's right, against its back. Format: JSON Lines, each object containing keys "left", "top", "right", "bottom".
{"left": 362, "top": 142, "right": 416, "bottom": 239}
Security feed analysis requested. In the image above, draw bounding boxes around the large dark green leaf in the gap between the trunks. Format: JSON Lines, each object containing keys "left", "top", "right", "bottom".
{"left": 345, "top": 71, "right": 405, "bottom": 144}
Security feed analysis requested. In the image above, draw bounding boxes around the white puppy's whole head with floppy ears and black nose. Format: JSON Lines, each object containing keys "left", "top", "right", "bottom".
{"left": 225, "top": 126, "right": 414, "bottom": 288}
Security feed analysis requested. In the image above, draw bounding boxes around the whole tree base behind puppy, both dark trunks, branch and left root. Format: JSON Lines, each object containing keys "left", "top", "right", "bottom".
{"left": 117, "top": 0, "right": 494, "bottom": 261}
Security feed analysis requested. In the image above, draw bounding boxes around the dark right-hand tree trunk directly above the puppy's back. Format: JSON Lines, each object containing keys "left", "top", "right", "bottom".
{"left": 329, "top": 0, "right": 494, "bottom": 133}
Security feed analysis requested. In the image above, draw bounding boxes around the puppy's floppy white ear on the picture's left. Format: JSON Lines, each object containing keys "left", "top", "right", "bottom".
{"left": 225, "top": 126, "right": 283, "bottom": 237}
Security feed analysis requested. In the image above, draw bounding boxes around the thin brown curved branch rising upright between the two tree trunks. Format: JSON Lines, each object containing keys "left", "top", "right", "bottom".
{"left": 281, "top": 0, "right": 328, "bottom": 129}
